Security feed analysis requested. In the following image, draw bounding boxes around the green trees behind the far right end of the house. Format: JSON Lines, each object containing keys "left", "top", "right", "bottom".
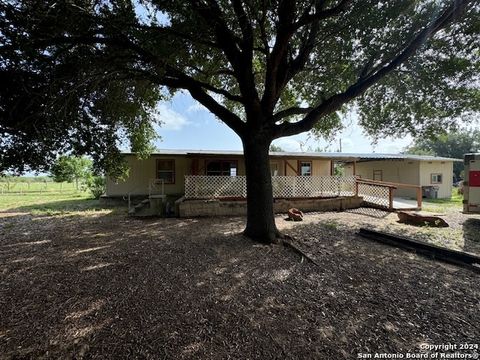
{"left": 405, "top": 129, "right": 480, "bottom": 180}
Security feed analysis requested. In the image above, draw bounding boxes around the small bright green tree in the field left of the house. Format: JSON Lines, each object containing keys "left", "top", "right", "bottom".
{"left": 50, "top": 156, "right": 92, "bottom": 190}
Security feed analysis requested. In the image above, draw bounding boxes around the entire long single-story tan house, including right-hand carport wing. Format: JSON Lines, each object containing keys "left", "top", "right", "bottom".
{"left": 106, "top": 150, "right": 461, "bottom": 198}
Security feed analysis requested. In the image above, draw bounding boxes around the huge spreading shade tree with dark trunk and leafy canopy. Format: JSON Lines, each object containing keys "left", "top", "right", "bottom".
{"left": 0, "top": 0, "right": 480, "bottom": 242}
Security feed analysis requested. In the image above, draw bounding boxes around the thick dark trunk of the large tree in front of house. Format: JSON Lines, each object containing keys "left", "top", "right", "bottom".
{"left": 243, "top": 137, "right": 281, "bottom": 244}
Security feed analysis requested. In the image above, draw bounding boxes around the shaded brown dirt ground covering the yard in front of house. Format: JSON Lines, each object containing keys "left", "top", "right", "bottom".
{"left": 0, "top": 210, "right": 480, "bottom": 359}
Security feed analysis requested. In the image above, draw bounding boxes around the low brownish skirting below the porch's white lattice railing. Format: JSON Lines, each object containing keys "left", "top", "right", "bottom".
{"left": 176, "top": 196, "right": 363, "bottom": 217}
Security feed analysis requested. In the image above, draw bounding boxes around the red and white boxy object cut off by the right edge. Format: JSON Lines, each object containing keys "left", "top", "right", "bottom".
{"left": 463, "top": 154, "right": 480, "bottom": 213}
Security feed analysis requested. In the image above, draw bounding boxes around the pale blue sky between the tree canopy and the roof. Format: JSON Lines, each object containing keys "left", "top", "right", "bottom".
{"left": 155, "top": 92, "right": 412, "bottom": 154}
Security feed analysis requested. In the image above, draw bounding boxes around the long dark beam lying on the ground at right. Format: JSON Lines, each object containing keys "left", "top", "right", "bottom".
{"left": 358, "top": 228, "right": 480, "bottom": 273}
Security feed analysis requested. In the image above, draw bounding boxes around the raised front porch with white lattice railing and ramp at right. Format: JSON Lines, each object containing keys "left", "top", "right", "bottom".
{"left": 176, "top": 175, "right": 422, "bottom": 217}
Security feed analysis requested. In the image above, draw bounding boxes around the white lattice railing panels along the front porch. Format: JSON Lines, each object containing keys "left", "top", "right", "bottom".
{"left": 185, "top": 175, "right": 355, "bottom": 199}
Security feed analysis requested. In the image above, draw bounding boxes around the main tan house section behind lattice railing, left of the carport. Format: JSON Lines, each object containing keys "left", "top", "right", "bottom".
{"left": 106, "top": 150, "right": 344, "bottom": 196}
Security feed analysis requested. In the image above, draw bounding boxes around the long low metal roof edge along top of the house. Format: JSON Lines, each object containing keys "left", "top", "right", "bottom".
{"left": 125, "top": 149, "right": 463, "bottom": 162}
